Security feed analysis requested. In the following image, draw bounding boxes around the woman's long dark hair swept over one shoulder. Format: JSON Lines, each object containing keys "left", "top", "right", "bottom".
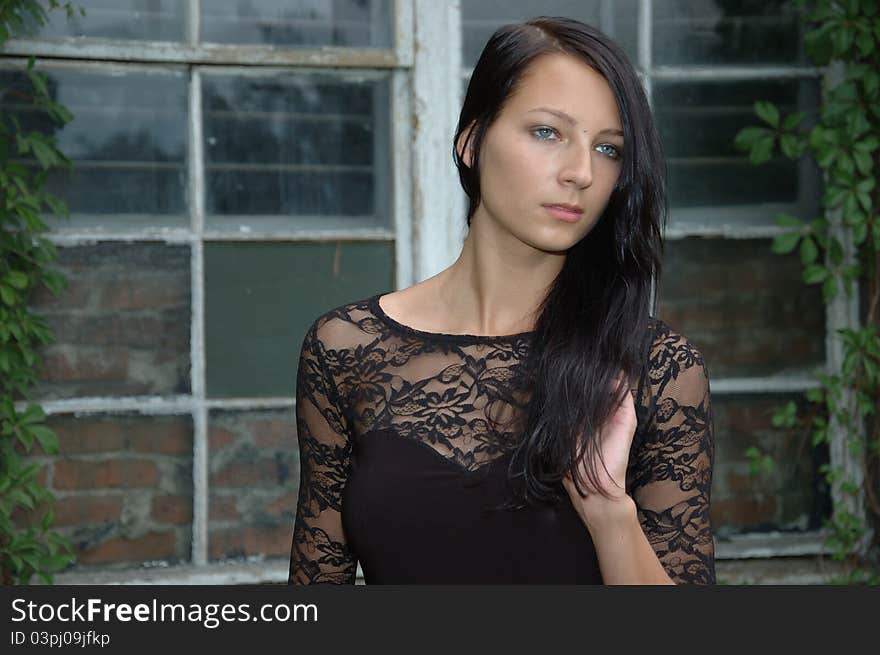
{"left": 453, "top": 16, "right": 668, "bottom": 506}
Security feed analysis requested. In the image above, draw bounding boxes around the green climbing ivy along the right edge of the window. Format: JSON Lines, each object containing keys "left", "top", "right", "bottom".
{"left": 734, "top": 0, "right": 880, "bottom": 583}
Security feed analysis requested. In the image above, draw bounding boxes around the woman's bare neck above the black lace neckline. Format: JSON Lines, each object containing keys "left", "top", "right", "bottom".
{"left": 437, "top": 207, "right": 566, "bottom": 335}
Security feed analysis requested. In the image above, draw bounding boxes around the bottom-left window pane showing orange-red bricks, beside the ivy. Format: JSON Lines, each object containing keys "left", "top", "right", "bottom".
{"left": 19, "top": 414, "right": 193, "bottom": 569}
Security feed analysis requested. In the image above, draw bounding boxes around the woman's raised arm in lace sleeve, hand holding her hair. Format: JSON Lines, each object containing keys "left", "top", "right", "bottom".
{"left": 563, "top": 324, "right": 715, "bottom": 584}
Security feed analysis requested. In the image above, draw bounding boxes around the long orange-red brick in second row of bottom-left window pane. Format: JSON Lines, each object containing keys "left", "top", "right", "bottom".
{"left": 53, "top": 459, "right": 159, "bottom": 489}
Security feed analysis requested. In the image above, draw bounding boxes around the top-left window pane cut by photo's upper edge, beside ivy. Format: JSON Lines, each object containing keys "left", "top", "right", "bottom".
{"left": 24, "top": 0, "right": 187, "bottom": 41}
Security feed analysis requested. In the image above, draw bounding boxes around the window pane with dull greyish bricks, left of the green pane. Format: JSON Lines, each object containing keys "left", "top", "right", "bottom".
{"left": 32, "top": 242, "right": 190, "bottom": 399}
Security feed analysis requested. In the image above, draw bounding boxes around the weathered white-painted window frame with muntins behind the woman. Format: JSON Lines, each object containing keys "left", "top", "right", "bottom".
{"left": 0, "top": 0, "right": 864, "bottom": 582}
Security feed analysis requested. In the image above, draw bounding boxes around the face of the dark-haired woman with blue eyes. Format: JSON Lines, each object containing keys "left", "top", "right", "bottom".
{"left": 462, "top": 53, "right": 623, "bottom": 253}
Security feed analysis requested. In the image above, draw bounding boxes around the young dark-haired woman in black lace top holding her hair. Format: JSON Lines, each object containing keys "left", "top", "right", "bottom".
{"left": 289, "top": 17, "right": 715, "bottom": 584}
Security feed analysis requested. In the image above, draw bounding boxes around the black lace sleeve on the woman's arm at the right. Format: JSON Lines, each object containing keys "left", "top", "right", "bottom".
{"left": 630, "top": 322, "right": 715, "bottom": 584}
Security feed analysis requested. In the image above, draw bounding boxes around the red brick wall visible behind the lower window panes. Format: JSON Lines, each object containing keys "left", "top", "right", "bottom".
{"left": 10, "top": 238, "right": 840, "bottom": 570}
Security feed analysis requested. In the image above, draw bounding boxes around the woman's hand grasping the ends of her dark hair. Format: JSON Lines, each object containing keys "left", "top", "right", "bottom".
{"left": 562, "top": 375, "right": 637, "bottom": 525}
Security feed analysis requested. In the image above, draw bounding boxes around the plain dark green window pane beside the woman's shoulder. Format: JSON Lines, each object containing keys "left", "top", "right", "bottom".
{"left": 205, "top": 242, "right": 394, "bottom": 398}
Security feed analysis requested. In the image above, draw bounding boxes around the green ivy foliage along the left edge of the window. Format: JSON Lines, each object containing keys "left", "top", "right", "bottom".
{"left": 0, "top": 0, "right": 83, "bottom": 584}
